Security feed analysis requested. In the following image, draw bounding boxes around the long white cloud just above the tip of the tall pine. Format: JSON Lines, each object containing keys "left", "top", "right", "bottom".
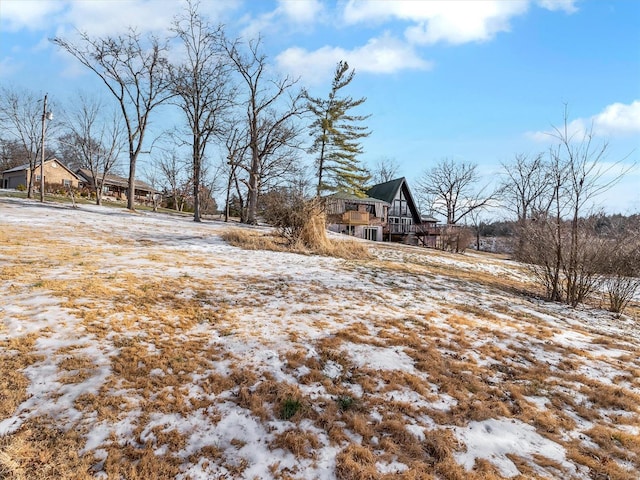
{"left": 276, "top": 35, "right": 432, "bottom": 84}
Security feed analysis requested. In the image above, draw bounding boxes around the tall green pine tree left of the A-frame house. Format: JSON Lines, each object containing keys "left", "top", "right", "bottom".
{"left": 307, "top": 61, "right": 371, "bottom": 195}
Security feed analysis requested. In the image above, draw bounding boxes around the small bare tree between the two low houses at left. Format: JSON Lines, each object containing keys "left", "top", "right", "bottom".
{"left": 62, "top": 94, "right": 125, "bottom": 205}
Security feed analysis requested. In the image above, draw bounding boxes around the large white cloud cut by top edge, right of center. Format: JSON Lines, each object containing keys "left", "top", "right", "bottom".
{"left": 343, "top": 0, "right": 575, "bottom": 45}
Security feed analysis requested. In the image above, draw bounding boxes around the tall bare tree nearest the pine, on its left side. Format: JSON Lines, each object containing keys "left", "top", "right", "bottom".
{"left": 225, "top": 39, "right": 306, "bottom": 224}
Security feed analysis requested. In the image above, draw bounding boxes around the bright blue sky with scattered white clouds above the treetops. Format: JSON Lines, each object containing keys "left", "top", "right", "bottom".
{"left": 0, "top": 0, "right": 640, "bottom": 213}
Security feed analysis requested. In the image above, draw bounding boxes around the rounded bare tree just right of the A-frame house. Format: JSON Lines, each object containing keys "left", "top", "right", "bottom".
{"left": 416, "top": 158, "right": 500, "bottom": 225}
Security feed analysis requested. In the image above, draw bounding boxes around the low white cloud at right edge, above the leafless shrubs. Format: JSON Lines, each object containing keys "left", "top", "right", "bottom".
{"left": 527, "top": 100, "right": 640, "bottom": 142}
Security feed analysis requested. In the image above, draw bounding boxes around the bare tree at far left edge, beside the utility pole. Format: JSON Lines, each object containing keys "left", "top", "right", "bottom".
{"left": 0, "top": 88, "right": 50, "bottom": 198}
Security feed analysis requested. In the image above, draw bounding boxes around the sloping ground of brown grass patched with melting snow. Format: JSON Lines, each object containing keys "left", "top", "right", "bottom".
{"left": 0, "top": 197, "right": 640, "bottom": 479}
